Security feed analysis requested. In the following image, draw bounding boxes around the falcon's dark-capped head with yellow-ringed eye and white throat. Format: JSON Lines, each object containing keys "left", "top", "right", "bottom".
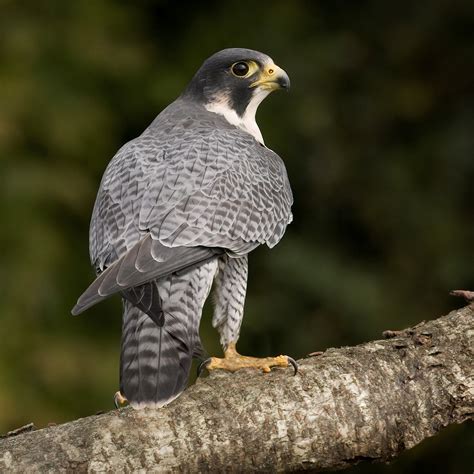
{"left": 182, "top": 48, "right": 290, "bottom": 143}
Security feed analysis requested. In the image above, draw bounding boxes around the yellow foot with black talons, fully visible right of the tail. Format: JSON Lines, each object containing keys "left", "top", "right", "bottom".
{"left": 198, "top": 343, "right": 298, "bottom": 376}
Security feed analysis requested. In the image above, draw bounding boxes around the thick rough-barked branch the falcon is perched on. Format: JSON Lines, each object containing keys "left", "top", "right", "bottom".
{"left": 0, "top": 305, "right": 474, "bottom": 472}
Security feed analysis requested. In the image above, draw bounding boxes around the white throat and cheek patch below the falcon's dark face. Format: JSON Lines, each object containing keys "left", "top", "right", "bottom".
{"left": 205, "top": 89, "right": 270, "bottom": 145}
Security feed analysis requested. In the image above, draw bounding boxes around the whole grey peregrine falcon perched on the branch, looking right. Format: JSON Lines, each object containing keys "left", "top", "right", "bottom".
{"left": 72, "top": 48, "right": 296, "bottom": 407}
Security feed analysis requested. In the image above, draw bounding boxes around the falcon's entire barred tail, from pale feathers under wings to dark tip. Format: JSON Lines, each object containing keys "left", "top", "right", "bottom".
{"left": 120, "top": 259, "right": 218, "bottom": 407}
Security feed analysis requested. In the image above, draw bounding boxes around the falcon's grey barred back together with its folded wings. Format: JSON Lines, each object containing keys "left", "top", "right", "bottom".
{"left": 75, "top": 101, "right": 292, "bottom": 312}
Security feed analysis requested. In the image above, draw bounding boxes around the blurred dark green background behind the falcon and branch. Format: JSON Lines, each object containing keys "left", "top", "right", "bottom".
{"left": 0, "top": 0, "right": 474, "bottom": 473}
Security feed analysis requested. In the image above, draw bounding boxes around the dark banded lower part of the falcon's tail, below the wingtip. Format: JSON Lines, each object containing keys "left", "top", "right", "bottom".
{"left": 120, "top": 300, "right": 195, "bottom": 408}
